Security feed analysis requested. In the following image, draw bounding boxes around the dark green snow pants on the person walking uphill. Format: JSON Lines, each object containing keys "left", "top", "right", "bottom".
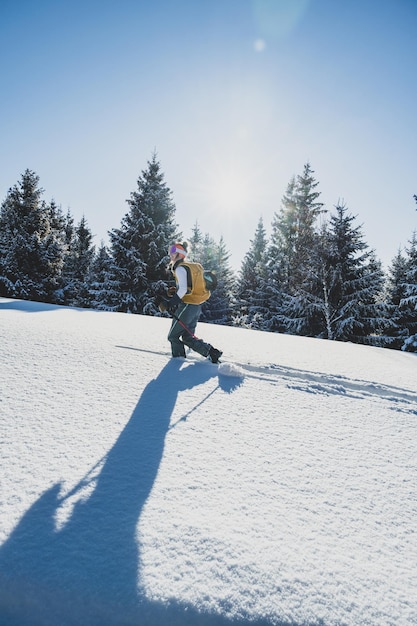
{"left": 168, "top": 302, "right": 211, "bottom": 356}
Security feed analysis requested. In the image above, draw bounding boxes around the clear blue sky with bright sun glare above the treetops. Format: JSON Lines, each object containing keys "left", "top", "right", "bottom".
{"left": 0, "top": 0, "right": 417, "bottom": 269}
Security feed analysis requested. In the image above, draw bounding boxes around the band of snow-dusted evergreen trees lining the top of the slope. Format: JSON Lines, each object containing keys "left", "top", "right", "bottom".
{"left": 0, "top": 154, "right": 417, "bottom": 352}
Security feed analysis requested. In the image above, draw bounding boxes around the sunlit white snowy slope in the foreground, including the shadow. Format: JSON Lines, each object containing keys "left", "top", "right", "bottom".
{"left": 0, "top": 298, "right": 417, "bottom": 626}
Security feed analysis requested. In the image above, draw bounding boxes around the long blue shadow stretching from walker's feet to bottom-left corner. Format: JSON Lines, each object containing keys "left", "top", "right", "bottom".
{"left": 0, "top": 360, "right": 302, "bottom": 626}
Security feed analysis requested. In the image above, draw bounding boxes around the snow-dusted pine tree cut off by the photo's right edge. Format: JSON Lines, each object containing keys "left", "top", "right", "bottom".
{"left": 400, "top": 231, "right": 417, "bottom": 352}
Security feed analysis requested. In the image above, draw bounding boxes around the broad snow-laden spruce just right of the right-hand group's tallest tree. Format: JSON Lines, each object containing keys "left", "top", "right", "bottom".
{"left": 287, "top": 204, "right": 386, "bottom": 345}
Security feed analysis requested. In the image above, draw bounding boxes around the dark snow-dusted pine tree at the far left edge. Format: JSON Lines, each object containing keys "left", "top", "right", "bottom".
{"left": 0, "top": 169, "right": 63, "bottom": 302}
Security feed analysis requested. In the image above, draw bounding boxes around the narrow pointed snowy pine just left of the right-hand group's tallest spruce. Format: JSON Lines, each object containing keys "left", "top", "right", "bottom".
{"left": 234, "top": 217, "right": 269, "bottom": 329}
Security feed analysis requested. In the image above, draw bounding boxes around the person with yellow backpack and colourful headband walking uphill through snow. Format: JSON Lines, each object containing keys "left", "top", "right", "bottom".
{"left": 162, "top": 243, "right": 223, "bottom": 363}
